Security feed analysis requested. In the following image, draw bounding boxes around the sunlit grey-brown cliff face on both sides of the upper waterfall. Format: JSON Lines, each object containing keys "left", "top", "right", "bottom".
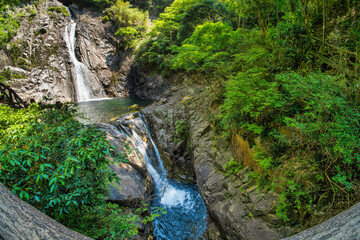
{"left": 0, "top": 0, "right": 127, "bottom": 102}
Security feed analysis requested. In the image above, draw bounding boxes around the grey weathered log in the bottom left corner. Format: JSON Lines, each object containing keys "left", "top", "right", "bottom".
{"left": 0, "top": 183, "right": 91, "bottom": 240}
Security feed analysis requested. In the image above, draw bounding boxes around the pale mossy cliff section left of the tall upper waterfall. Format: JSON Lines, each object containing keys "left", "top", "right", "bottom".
{"left": 7, "top": 0, "right": 74, "bottom": 102}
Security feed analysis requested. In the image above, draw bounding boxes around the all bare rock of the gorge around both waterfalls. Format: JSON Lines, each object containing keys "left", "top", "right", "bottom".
{"left": 0, "top": 0, "right": 360, "bottom": 240}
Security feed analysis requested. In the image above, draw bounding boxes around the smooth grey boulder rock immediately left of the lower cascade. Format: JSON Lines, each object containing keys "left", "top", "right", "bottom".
{"left": 96, "top": 119, "right": 153, "bottom": 240}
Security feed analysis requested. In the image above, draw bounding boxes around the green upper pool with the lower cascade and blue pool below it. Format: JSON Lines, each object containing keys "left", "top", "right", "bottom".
{"left": 77, "top": 98, "right": 208, "bottom": 240}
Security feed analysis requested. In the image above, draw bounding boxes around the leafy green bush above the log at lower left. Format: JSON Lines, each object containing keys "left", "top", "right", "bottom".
{"left": 0, "top": 105, "right": 123, "bottom": 218}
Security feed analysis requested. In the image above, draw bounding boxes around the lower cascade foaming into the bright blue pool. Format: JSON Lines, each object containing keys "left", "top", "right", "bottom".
{"left": 117, "top": 115, "right": 207, "bottom": 240}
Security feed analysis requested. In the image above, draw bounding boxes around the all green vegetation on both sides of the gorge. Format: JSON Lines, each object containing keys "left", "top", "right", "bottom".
{"left": 0, "top": 0, "right": 360, "bottom": 234}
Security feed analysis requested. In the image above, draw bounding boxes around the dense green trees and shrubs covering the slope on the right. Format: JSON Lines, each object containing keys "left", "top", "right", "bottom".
{"left": 137, "top": 0, "right": 360, "bottom": 221}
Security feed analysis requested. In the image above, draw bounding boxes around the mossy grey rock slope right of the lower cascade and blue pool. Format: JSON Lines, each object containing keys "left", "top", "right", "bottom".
{"left": 143, "top": 83, "right": 288, "bottom": 240}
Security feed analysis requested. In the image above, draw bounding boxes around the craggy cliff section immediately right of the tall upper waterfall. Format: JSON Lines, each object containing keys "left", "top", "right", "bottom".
{"left": 70, "top": 5, "right": 129, "bottom": 97}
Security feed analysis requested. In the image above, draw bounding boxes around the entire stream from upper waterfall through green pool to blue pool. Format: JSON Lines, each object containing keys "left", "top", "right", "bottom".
{"left": 64, "top": 6, "right": 208, "bottom": 240}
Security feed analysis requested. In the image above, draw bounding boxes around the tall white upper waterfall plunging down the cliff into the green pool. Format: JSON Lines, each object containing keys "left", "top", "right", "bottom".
{"left": 65, "top": 9, "right": 106, "bottom": 102}
